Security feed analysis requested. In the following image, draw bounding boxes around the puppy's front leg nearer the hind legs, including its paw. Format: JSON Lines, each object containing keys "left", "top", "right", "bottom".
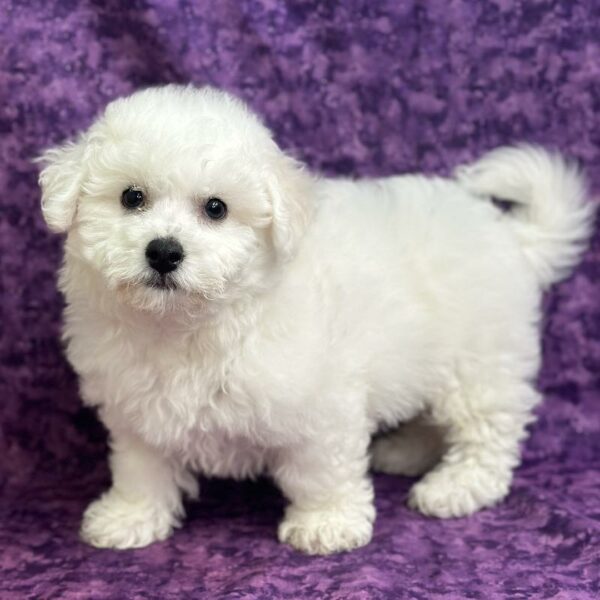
{"left": 273, "top": 432, "right": 375, "bottom": 554}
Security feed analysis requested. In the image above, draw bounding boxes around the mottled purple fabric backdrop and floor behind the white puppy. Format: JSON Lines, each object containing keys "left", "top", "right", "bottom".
{"left": 0, "top": 0, "right": 600, "bottom": 600}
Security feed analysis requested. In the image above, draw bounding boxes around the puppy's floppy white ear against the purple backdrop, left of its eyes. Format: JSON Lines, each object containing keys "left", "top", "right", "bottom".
{"left": 36, "top": 139, "right": 85, "bottom": 233}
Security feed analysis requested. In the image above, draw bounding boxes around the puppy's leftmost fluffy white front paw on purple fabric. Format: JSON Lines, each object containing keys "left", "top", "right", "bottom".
{"left": 80, "top": 490, "right": 179, "bottom": 549}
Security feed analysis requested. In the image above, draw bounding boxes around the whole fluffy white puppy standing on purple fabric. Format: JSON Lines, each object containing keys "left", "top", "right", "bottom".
{"left": 40, "top": 86, "right": 592, "bottom": 554}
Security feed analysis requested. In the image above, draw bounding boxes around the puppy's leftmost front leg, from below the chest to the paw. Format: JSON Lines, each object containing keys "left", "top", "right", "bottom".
{"left": 81, "top": 432, "right": 198, "bottom": 549}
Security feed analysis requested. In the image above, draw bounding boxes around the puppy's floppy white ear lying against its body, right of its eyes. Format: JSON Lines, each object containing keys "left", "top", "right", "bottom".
{"left": 267, "top": 151, "right": 315, "bottom": 260}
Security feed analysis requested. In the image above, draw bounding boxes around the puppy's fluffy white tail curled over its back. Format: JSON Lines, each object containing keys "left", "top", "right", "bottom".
{"left": 455, "top": 146, "right": 595, "bottom": 288}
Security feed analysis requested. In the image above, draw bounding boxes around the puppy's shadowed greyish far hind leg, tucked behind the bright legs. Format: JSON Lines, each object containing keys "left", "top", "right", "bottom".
{"left": 371, "top": 418, "right": 444, "bottom": 477}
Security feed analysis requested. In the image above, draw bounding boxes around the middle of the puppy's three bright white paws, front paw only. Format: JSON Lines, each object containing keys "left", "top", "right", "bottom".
{"left": 278, "top": 506, "right": 375, "bottom": 554}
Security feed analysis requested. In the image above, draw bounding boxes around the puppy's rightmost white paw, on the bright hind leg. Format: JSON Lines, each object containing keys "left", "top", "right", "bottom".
{"left": 408, "top": 464, "right": 510, "bottom": 519}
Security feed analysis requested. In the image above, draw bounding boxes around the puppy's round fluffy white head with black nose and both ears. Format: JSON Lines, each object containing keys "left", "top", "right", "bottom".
{"left": 40, "top": 86, "right": 312, "bottom": 310}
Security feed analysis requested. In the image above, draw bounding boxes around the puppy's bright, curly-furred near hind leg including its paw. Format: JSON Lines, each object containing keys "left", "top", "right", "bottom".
{"left": 409, "top": 372, "right": 539, "bottom": 518}
